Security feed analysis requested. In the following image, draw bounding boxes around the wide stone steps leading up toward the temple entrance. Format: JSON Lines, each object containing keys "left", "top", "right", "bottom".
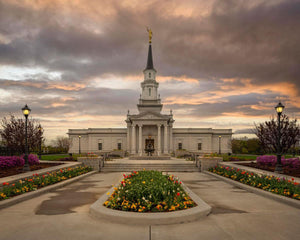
{"left": 101, "top": 160, "right": 199, "bottom": 172}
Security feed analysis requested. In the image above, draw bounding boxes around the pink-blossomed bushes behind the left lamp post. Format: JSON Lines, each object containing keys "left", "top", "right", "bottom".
{"left": 0, "top": 154, "right": 40, "bottom": 169}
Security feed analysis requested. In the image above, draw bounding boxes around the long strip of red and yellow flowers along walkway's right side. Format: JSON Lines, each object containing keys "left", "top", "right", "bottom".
{"left": 209, "top": 166, "right": 300, "bottom": 200}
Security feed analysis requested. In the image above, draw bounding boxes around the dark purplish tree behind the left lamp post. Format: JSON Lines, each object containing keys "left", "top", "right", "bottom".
{"left": 0, "top": 114, "right": 44, "bottom": 154}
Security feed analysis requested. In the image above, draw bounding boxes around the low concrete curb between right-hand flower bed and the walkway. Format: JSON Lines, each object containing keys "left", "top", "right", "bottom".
{"left": 204, "top": 171, "right": 300, "bottom": 209}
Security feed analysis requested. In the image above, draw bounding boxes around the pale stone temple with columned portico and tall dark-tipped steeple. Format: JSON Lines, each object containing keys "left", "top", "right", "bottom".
{"left": 68, "top": 30, "right": 232, "bottom": 156}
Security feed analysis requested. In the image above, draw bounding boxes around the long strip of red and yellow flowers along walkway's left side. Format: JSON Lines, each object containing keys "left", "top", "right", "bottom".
{"left": 0, "top": 166, "right": 92, "bottom": 201}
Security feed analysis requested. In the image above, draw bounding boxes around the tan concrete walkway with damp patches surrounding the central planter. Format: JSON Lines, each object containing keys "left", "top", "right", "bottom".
{"left": 0, "top": 172, "right": 300, "bottom": 240}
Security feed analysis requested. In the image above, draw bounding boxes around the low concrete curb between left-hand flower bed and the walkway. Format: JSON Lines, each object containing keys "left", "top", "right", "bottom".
{"left": 0, "top": 171, "right": 96, "bottom": 209}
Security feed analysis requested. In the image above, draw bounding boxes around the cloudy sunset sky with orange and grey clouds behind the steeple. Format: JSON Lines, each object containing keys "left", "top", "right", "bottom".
{"left": 0, "top": 0, "right": 300, "bottom": 140}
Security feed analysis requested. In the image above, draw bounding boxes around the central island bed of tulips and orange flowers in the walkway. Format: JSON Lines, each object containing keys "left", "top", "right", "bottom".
{"left": 103, "top": 171, "right": 196, "bottom": 212}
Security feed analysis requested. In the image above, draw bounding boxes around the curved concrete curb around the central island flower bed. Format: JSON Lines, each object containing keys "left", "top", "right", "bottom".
{"left": 90, "top": 182, "right": 211, "bottom": 225}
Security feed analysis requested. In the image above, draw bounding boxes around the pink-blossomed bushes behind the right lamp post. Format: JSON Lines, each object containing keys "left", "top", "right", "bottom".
{"left": 256, "top": 155, "right": 300, "bottom": 168}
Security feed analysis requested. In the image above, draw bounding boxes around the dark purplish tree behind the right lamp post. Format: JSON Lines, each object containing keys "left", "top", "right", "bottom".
{"left": 254, "top": 114, "right": 300, "bottom": 153}
